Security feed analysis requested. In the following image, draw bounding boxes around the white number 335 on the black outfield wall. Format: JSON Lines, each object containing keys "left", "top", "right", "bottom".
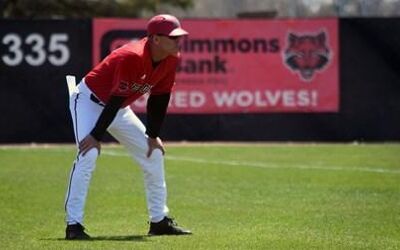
{"left": 1, "top": 33, "right": 70, "bottom": 66}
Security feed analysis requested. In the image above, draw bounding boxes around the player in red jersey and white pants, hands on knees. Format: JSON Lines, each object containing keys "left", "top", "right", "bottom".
{"left": 65, "top": 15, "right": 191, "bottom": 240}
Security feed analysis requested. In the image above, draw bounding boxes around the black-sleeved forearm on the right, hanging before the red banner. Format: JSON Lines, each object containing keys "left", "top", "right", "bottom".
{"left": 146, "top": 93, "right": 171, "bottom": 138}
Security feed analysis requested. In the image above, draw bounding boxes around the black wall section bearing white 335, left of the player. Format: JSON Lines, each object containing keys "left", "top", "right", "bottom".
{"left": 0, "top": 20, "right": 92, "bottom": 142}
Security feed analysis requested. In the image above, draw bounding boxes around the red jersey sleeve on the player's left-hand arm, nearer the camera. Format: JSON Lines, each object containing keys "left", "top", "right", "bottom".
{"left": 111, "top": 56, "right": 138, "bottom": 97}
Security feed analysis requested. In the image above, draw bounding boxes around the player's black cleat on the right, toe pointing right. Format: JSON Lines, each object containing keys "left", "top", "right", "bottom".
{"left": 148, "top": 216, "right": 192, "bottom": 236}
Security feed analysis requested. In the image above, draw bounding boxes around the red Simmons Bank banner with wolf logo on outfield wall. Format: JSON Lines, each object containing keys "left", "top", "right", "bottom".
{"left": 93, "top": 19, "right": 339, "bottom": 113}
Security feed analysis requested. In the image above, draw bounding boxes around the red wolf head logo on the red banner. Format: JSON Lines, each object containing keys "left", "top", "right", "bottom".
{"left": 284, "top": 31, "right": 330, "bottom": 82}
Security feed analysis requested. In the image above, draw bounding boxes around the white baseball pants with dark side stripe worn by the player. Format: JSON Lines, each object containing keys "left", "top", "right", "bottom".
{"left": 65, "top": 80, "right": 168, "bottom": 224}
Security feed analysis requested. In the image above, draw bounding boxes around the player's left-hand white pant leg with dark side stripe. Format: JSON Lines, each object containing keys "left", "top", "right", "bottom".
{"left": 65, "top": 90, "right": 103, "bottom": 224}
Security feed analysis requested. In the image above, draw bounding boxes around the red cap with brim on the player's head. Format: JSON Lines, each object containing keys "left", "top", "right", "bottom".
{"left": 147, "top": 14, "right": 189, "bottom": 36}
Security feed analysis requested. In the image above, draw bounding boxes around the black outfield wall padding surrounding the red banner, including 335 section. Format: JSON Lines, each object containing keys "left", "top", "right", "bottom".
{"left": 0, "top": 18, "right": 400, "bottom": 143}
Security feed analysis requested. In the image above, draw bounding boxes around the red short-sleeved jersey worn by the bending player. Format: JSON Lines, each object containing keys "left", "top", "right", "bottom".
{"left": 85, "top": 38, "right": 178, "bottom": 107}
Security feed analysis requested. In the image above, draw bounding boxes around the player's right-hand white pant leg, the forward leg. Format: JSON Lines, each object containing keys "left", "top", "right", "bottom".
{"left": 108, "top": 108, "right": 168, "bottom": 222}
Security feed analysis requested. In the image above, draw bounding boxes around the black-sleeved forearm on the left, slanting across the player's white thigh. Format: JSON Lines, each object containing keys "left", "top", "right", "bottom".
{"left": 90, "top": 96, "right": 125, "bottom": 141}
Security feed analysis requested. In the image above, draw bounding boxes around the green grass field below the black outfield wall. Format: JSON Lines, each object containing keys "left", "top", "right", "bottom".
{"left": 0, "top": 144, "right": 400, "bottom": 250}
